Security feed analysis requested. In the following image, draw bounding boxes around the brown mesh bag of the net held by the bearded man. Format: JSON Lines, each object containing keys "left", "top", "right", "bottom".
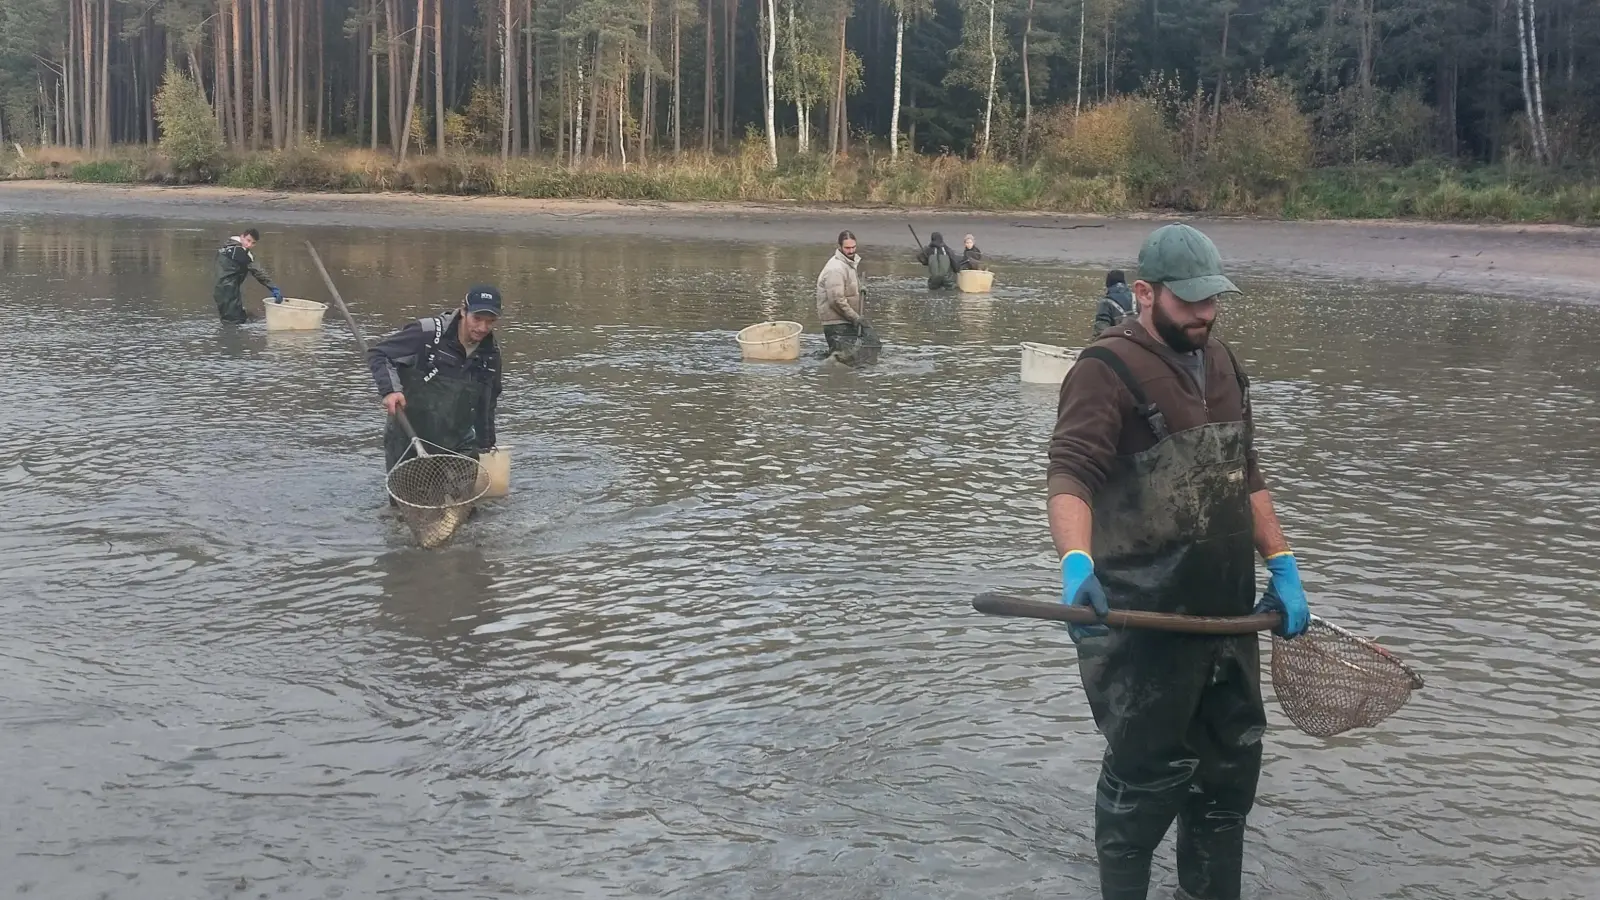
{"left": 1272, "top": 618, "right": 1422, "bottom": 737}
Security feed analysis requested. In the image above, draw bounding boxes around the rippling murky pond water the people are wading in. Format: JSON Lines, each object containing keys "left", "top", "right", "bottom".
{"left": 0, "top": 218, "right": 1600, "bottom": 900}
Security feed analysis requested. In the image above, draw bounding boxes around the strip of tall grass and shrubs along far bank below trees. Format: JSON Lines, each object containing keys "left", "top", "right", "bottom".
{"left": 0, "top": 141, "right": 1600, "bottom": 224}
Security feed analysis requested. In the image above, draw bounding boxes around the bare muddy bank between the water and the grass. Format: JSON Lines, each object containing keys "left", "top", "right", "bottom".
{"left": 0, "top": 181, "right": 1600, "bottom": 301}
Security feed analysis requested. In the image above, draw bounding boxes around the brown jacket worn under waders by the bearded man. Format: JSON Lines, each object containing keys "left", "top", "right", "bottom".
{"left": 1048, "top": 317, "right": 1267, "bottom": 508}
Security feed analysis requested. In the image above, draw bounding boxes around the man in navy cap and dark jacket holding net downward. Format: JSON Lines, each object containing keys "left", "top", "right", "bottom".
{"left": 366, "top": 285, "right": 501, "bottom": 483}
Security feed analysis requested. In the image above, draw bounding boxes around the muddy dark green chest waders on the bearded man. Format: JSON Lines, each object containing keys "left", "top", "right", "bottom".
{"left": 1078, "top": 348, "right": 1266, "bottom": 900}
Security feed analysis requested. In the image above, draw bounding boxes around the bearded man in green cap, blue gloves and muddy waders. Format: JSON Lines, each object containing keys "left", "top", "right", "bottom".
{"left": 1048, "top": 224, "right": 1309, "bottom": 900}
